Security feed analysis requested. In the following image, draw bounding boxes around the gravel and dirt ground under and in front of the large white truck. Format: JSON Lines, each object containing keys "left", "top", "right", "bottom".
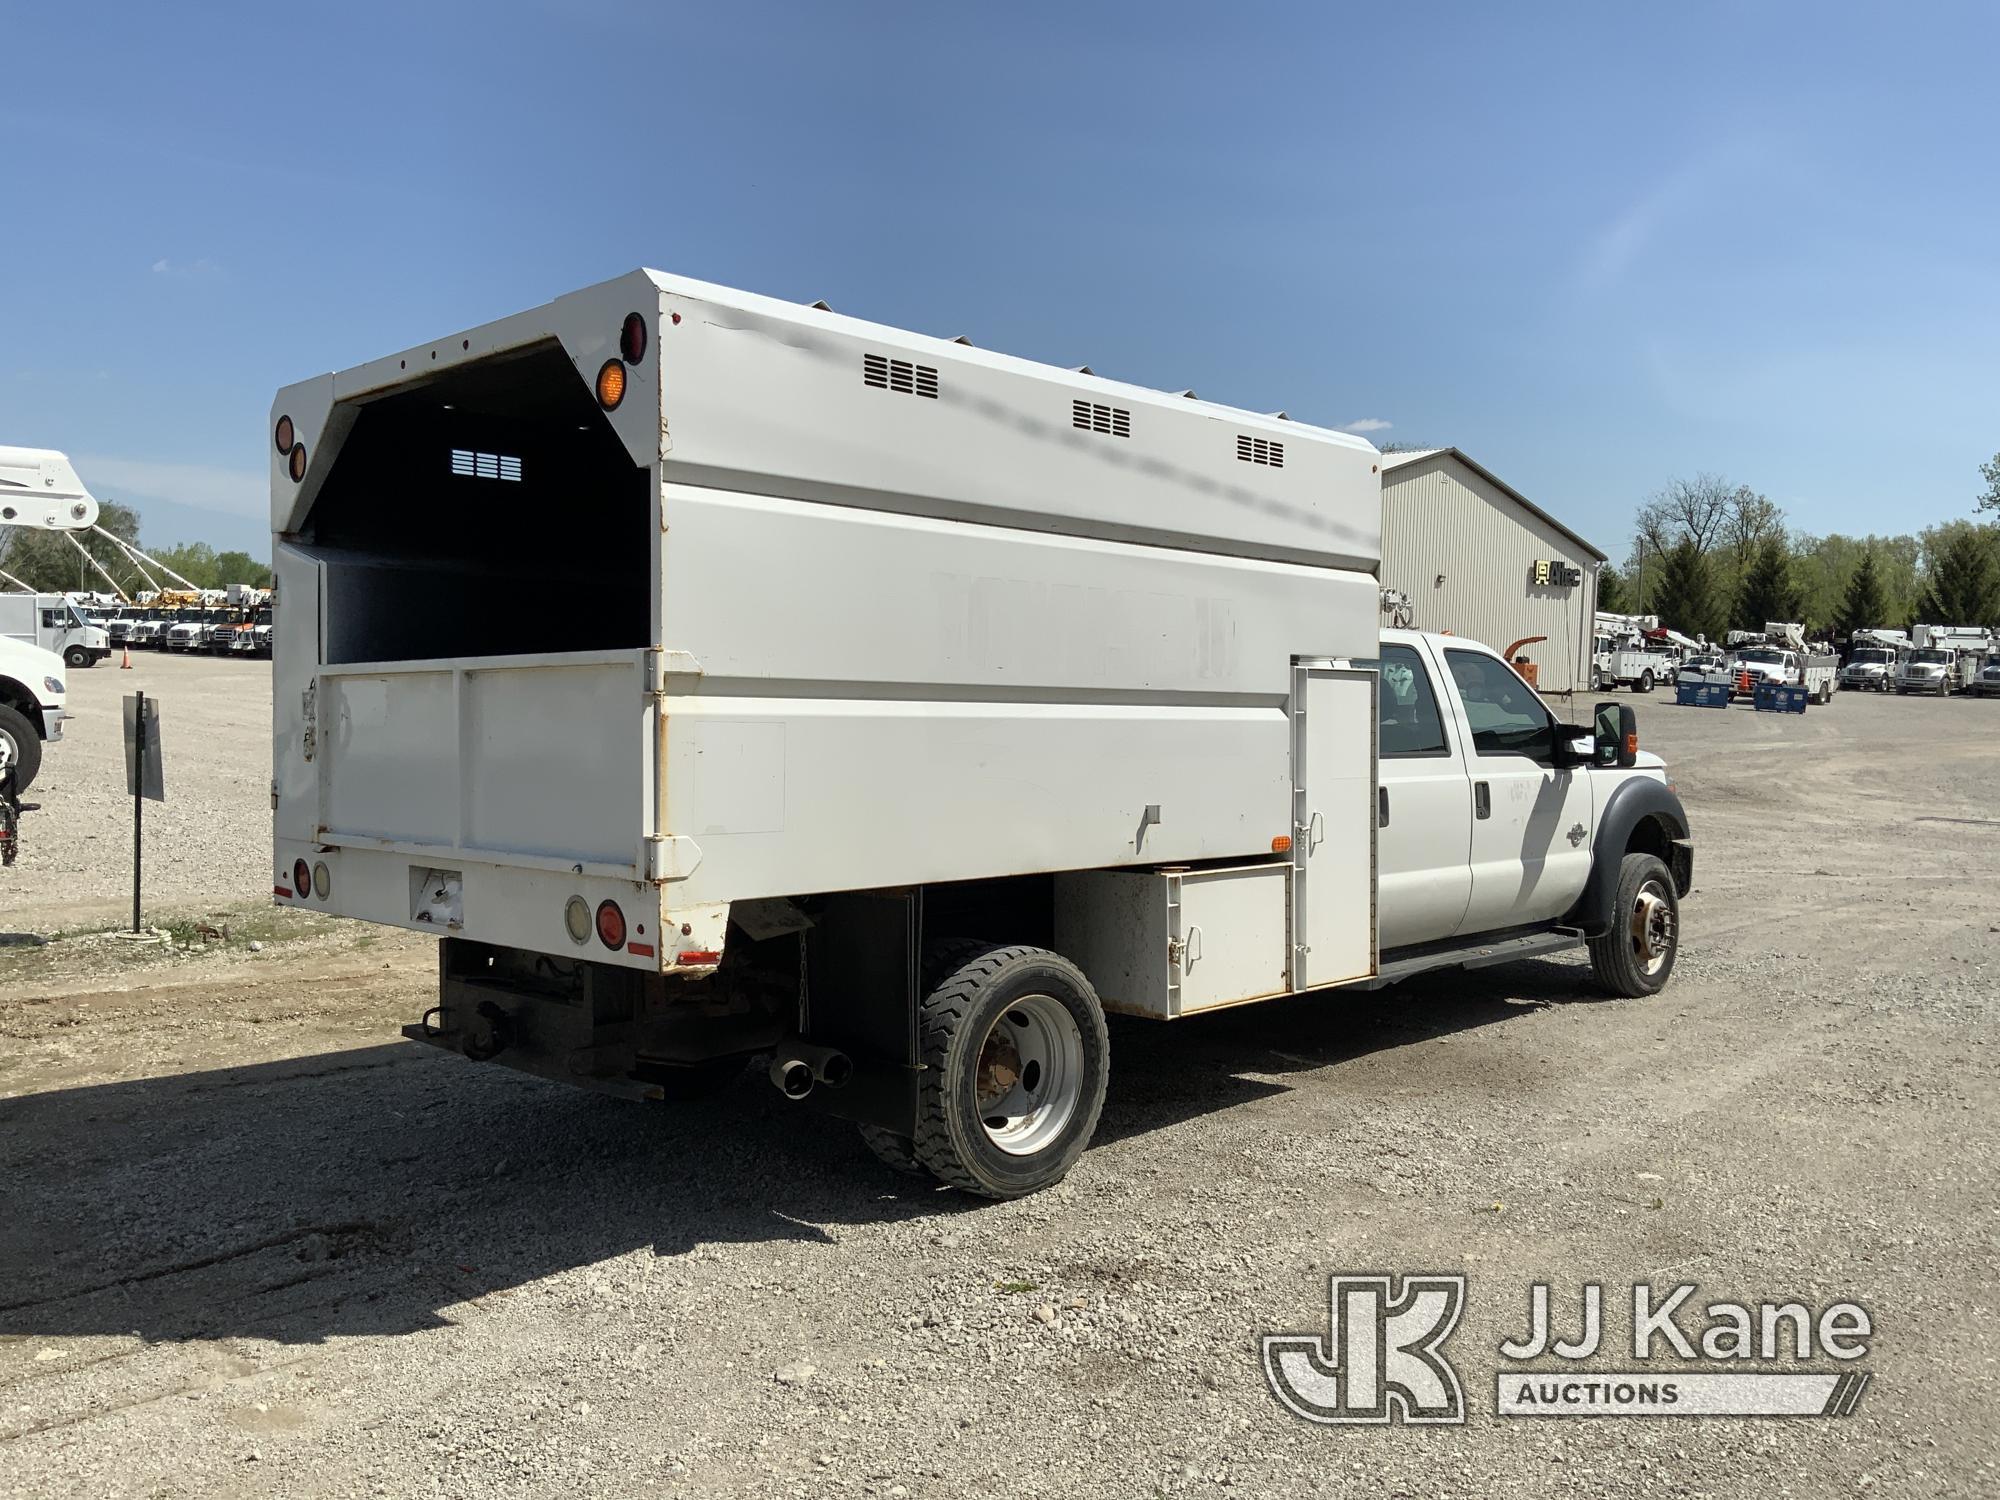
{"left": 0, "top": 688, "right": 2000, "bottom": 1498}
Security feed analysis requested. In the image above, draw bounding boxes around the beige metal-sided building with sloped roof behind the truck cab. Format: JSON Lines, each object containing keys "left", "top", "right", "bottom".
{"left": 1382, "top": 448, "right": 1604, "bottom": 694}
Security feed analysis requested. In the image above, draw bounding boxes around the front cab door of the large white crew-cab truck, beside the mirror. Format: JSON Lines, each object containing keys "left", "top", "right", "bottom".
{"left": 1444, "top": 646, "right": 1594, "bottom": 936}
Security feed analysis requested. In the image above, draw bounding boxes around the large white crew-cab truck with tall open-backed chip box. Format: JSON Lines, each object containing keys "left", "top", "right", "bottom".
{"left": 270, "top": 272, "right": 1692, "bottom": 1198}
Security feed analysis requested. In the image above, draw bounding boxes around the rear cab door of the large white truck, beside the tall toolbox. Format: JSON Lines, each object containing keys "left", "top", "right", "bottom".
{"left": 1376, "top": 642, "right": 1472, "bottom": 950}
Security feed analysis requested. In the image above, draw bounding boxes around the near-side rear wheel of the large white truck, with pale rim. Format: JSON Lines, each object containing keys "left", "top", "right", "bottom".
{"left": 910, "top": 946, "right": 1110, "bottom": 1198}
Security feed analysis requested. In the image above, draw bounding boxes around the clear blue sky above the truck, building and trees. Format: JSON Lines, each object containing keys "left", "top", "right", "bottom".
{"left": 0, "top": 0, "right": 2000, "bottom": 556}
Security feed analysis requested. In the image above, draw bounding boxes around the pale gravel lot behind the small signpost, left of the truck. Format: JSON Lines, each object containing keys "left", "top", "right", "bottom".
{"left": 0, "top": 650, "right": 270, "bottom": 932}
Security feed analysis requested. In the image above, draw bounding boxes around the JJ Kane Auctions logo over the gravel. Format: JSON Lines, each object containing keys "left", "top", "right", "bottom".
{"left": 1264, "top": 1274, "right": 1874, "bottom": 1424}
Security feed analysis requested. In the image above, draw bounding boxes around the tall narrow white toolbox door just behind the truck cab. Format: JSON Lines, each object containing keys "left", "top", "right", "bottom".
{"left": 1292, "top": 668, "right": 1376, "bottom": 990}
